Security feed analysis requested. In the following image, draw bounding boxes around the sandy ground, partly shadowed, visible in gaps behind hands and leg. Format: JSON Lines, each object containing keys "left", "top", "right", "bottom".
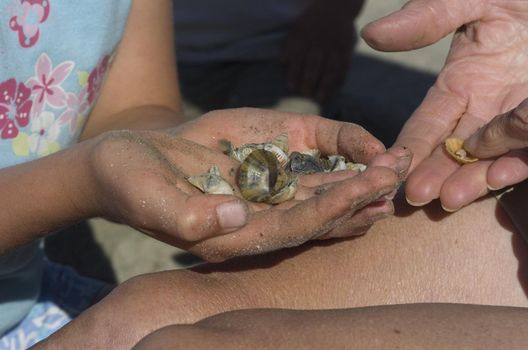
{"left": 45, "top": 0, "right": 450, "bottom": 282}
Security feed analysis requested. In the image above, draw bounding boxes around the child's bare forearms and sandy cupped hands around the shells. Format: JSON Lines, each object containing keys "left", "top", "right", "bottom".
{"left": 0, "top": 0, "right": 404, "bottom": 261}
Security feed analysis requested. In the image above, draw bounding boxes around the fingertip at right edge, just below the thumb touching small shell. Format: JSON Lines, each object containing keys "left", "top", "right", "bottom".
{"left": 487, "top": 149, "right": 528, "bottom": 190}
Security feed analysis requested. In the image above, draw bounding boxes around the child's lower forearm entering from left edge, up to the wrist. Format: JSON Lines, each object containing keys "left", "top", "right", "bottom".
{"left": 0, "top": 139, "right": 95, "bottom": 254}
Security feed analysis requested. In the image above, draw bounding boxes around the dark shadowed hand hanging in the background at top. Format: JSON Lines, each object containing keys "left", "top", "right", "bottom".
{"left": 283, "top": 0, "right": 363, "bottom": 100}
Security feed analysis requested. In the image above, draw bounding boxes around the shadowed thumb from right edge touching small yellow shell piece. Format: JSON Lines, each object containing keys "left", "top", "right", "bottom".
{"left": 464, "top": 99, "right": 528, "bottom": 158}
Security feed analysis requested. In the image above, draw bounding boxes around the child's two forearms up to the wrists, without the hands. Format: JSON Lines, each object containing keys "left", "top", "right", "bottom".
{"left": 0, "top": 0, "right": 183, "bottom": 253}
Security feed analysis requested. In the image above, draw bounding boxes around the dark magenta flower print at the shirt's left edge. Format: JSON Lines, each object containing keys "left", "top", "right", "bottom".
{"left": 0, "top": 79, "right": 33, "bottom": 139}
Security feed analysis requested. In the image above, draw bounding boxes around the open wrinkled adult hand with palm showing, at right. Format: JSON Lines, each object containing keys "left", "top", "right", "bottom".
{"left": 362, "top": 0, "right": 528, "bottom": 211}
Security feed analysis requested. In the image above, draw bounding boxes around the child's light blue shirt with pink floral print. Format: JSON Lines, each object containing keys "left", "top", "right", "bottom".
{"left": 0, "top": 0, "right": 132, "bottom": 334}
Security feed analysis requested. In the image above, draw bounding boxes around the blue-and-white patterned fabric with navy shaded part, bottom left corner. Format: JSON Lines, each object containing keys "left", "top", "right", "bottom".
{"left": 0, "top": 263, "right": 109, "bottom": 350}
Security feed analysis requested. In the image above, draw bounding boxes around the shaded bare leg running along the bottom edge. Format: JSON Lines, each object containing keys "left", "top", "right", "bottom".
{"left": 134, "top": 304, "right": 528, "bottom": 350}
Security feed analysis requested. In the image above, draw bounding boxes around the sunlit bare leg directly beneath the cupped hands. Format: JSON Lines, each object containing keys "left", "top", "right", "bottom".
{"left": 36, "top": 193, "right": 528, "bottom": 349}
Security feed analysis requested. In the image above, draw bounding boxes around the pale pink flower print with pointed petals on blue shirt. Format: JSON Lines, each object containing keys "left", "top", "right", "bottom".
{"left": 27, "top": 53, "right": 74, "bottom": 118}
